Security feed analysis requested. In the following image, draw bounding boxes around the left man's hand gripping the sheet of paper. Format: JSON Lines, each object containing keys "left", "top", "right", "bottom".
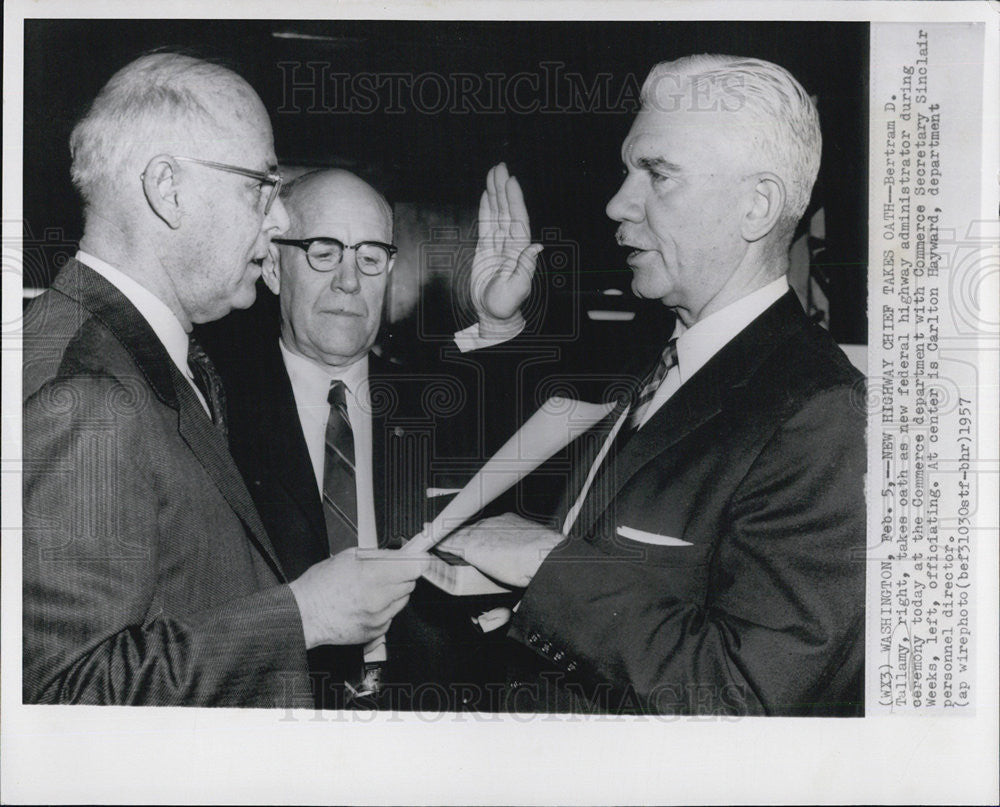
{"left": 289, "top": 548, "right": 429, "bottom": 648}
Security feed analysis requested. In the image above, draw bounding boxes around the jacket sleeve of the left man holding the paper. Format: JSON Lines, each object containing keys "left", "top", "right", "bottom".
{"left": 23, "top": 376, "right": 312, "bottom": 706}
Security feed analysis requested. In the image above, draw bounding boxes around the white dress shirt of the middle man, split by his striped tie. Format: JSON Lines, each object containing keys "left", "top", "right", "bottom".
{"left": 278, "top": 339, "right": 378, "bottom": 549}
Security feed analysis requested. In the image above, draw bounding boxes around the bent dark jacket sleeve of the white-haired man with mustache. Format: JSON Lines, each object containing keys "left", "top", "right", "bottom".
{"left": 510, "top": 388, "right": 866, "bottom": 714}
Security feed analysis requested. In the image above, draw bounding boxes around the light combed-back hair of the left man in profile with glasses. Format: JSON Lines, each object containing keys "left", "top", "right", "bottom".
{"left": 69, "top": 53, "right": 252, "bottom": 205}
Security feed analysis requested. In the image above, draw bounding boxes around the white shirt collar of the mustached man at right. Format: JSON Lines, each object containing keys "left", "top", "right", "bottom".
{"left": 674, "top": 275, "right": 788, "bottom": 384}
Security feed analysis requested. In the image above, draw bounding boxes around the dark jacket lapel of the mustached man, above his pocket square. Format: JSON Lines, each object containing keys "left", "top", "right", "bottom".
{"left": 573, "top": 290, "right": 806, "bottom": 535}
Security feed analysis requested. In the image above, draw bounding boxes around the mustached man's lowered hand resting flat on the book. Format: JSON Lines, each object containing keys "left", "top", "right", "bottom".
{"left": 438, "top": 513, "right": 565, "bottom": 588}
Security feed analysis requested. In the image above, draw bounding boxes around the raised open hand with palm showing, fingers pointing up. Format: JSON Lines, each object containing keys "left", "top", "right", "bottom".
{"left": 470, "top": 163, "right": 542, "bottom": 336}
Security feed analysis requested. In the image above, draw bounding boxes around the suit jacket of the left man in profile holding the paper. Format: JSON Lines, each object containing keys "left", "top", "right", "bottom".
{"left": 23, "top": 261, "right": 312, "bottom": 706}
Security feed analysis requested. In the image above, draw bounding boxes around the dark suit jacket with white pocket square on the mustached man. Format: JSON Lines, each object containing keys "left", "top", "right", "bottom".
{"left": 508, "top": 292, "right": 866, "bottom": 715}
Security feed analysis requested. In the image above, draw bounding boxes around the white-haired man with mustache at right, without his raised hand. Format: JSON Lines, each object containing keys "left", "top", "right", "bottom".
{"left": 445, "top": 56, "right": 866, "bottom": 715}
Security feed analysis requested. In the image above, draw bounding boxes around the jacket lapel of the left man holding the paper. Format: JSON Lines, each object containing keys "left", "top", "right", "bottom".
{"left": 52, "top": 261, "right": 284, "bottom": 580}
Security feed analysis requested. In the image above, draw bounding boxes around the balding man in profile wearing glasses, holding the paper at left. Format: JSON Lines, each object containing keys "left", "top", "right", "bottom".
{"left": 23, "top": 53, "right": 424, "bottom": 707}
